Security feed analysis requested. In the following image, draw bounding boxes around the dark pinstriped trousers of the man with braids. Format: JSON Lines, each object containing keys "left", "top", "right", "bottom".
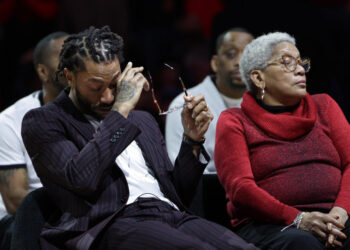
{"left": 95, "top": 198, "right": 257, "bottom": 250}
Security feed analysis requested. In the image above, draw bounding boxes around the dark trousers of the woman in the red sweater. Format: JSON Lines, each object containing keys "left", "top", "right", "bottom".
{"left": 235, "top": 220, "right": 350, "bottom": 250}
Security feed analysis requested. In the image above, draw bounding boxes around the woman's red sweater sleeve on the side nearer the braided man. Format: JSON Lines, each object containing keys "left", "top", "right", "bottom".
{"left": 214, "top": 110, "right": 299, "bottom": 225}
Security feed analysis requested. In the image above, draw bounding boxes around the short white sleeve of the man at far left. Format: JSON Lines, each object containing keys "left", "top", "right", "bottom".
{"left": 0, "top": 117, "right": 26, "bottom": 168}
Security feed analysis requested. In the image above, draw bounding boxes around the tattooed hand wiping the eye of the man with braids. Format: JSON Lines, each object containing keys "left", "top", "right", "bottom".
{"left": 112, "top": 62, "right": 150, "bottom": 118}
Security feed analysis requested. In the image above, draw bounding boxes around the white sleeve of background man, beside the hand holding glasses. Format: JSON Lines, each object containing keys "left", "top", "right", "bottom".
{"left": 165, "top": 95, "right": 184, "bottom": 164}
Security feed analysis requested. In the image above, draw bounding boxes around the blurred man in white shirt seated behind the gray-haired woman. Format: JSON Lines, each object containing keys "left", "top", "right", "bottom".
{"left": 165, "top": 28, "right": 253, "bottom": 174}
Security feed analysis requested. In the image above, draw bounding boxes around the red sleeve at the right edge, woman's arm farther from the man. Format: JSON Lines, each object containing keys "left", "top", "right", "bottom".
{"left": 326, "top": 95, "right": 350, "bottom": 214}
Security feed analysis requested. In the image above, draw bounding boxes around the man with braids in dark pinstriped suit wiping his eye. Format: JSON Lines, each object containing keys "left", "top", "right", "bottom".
{"left": 22, "top": 27, "right": 254, "bottom": 249}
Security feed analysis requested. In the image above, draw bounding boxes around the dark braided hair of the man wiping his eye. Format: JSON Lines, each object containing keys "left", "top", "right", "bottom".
{"left": 56, "top": 26, "right": 124, "bottom": 78}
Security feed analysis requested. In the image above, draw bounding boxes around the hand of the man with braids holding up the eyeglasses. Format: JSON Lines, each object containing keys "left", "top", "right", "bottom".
{"left": 181, "top": 95, "right": 214, "bottom": 141}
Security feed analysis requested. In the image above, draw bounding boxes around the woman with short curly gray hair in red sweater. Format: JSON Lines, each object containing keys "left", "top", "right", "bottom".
{"left": 214, "top": 32, "right": 350, "bottom": 249}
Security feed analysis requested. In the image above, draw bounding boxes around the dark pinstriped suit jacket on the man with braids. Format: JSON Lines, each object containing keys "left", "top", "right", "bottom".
{"left": 22, "top": 91, "right": 205, "bottom": 249}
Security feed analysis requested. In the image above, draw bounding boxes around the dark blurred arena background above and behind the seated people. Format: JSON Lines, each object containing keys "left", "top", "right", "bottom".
{"left": 0, "top": 0, "right": 350, "bottom": 132}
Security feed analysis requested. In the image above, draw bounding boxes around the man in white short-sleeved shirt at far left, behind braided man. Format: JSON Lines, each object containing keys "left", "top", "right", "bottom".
{"left": 0, "top": 32, "right": 67, "bottom": 249}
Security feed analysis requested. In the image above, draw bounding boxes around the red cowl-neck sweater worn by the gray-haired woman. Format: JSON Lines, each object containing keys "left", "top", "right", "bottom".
{"left": 214, "top": 93, "right": 350, "bottom": 226}
